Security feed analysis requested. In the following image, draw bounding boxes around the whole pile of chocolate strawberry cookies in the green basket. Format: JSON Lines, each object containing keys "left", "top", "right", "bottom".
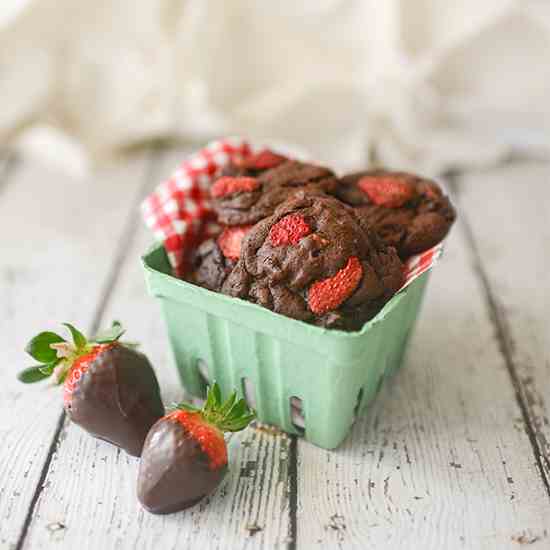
{"left": 188, "top": 150, "right": 456, "bottom": 330}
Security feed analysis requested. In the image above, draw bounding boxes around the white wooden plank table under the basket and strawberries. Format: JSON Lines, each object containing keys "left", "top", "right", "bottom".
{"left": 0, "top": 151, "right": 550, "bottom": 550}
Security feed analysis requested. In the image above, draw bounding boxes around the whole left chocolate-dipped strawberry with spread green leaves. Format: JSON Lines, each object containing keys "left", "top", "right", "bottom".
{"left": 18, "top": 322, "right": 164, "bottom": 456}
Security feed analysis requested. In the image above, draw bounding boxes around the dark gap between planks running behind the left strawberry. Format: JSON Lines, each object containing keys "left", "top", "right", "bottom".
{"left": 13, "top": 148, "right": 161, "bottom": 550}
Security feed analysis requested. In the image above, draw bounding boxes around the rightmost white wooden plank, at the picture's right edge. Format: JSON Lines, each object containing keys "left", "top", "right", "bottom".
{"left": 457, "top": 162, "right": 550, "bottom": 492}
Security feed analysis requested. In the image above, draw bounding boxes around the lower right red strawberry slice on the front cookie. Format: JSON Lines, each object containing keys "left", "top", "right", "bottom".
{"left": 308, "top": 256, "right": 363, "bottom": 315}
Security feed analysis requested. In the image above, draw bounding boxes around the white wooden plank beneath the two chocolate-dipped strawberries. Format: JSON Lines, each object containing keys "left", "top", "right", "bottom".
{"left": 22, "top": 153, "right": 292, "bottom": 550}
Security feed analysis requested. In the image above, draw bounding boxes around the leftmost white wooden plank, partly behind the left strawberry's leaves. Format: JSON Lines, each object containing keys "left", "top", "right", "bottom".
{"left": 0, "top": 152, "right": 155, "bottom": 548}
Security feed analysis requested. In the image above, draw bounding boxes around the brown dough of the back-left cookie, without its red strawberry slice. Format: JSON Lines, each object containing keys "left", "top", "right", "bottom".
{"left": 212, "top": 160, "right": 338, "bottom": 225}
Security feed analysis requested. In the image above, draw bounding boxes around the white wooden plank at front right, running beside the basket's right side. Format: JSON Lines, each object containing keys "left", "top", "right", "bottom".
{"left": 297, "top": 209, "right": 550, "bottom": 550}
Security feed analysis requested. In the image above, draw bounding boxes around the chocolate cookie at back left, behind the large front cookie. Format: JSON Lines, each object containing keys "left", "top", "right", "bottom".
{"left": 210, "top": 160, "right": 337, "bottom": 225}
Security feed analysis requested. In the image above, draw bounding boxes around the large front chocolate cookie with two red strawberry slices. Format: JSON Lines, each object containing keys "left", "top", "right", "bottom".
{"left": 222, "top": 194, "right": 404, "bottom": 330}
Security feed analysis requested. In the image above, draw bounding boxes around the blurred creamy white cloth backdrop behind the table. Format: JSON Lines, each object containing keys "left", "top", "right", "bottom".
{"left": 0, "top": 0, "right": 550, "bottom": 173}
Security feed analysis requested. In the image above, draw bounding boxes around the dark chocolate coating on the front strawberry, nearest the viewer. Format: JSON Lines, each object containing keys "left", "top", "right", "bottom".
{"left": 137, "top": 418, "right": 227, "bottom": 514}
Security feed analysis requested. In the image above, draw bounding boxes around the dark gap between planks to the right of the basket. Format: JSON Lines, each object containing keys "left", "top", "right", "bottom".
{"left": 446, "top": 172, "right": 550, "bottom": 498}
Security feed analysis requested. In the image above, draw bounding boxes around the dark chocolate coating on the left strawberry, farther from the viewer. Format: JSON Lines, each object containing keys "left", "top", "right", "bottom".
{"left": 66, "top": 343, "right": 164, "bottom": 456}
